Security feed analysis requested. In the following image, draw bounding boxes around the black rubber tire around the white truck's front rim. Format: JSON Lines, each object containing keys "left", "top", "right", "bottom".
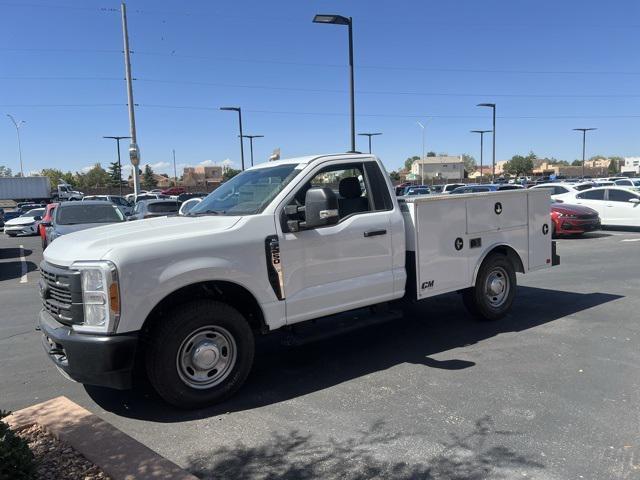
{"left": 145, "top": 300, "right": 254, "bottom": 409}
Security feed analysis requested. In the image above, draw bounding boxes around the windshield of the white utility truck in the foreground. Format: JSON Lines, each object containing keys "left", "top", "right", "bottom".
{"left": 187, "top": 163, "right": 300, "bottom": 216}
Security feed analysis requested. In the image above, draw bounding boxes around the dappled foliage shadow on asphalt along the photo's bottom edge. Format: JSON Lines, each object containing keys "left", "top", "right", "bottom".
{"left": 187, "top": 416, "right": 545, "bottom": 480}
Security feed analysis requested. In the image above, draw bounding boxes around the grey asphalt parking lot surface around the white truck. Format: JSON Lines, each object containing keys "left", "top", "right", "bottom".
{"left": 0, "top": 232, "right": 640, "bottom": 480}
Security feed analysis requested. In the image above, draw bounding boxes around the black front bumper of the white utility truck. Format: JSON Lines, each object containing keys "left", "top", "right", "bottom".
{"left": 38, "top": 310, "right": 138, "bottom": 390}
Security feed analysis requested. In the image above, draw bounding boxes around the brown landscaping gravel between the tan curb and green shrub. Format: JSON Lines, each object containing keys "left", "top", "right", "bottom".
{"left": 16, "top": 425, "right": 110, "bottom": 480}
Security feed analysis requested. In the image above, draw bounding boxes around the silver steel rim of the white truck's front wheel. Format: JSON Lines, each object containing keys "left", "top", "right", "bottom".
{"left": 176, "top": 325, "right": 238, "bottom": 390}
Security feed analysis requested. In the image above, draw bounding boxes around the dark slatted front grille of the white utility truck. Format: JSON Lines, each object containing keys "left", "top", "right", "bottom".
{"left": 40, "top": 261, "right": 84, "bottom": 325}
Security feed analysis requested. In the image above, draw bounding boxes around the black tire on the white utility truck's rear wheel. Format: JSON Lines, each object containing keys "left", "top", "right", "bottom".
{"left": 462, "top": 253, "right": 517, "bottom": 320}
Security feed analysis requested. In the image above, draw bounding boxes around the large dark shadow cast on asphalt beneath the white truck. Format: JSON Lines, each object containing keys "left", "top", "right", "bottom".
{"left": 85, "top": 286, "right": 622, "bottom": 422}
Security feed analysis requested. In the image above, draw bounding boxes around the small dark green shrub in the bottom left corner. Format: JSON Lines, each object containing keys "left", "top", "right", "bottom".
{"left": 0, "top": 410, "right": 36, "bottom": 480}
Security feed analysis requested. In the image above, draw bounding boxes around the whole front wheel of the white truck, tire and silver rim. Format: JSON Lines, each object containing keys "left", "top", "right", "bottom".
{"left": 146, "top": 300, "right": 254, "bottom": 408}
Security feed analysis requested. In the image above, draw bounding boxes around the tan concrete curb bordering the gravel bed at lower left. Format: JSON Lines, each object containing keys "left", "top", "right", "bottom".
{"left": 3, "top": 397, "right": 198, "bottom": 480}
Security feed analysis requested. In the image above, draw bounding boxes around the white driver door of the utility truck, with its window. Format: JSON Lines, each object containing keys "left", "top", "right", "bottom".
{"left": 278, "top": 160, "right": 394, "bottom": 324}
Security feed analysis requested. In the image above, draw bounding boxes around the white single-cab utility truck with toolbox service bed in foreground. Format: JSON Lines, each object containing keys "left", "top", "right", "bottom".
{"left": 38, "top": 154, "right": 559, "bottom": 408}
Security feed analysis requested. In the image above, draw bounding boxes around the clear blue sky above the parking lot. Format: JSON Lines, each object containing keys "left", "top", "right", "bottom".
{"left": 0, "top": 0, "right": 640, "bottom": 176}
